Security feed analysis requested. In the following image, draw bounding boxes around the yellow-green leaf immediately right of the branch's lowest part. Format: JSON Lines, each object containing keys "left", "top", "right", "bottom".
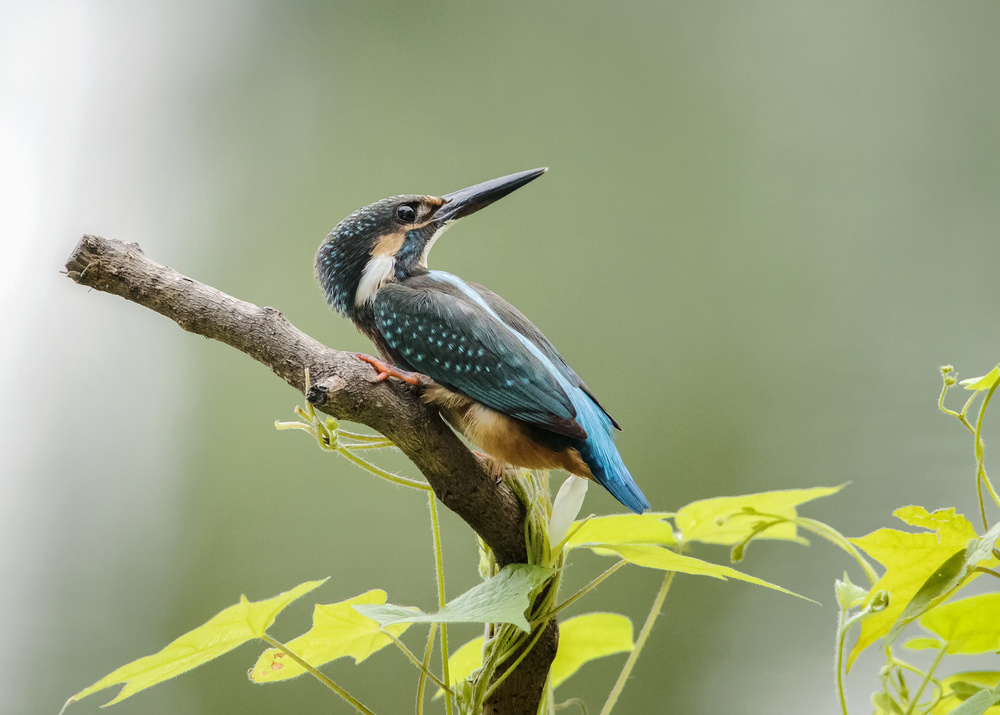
{"left": 549, "top": 613, "right": 635, "bottom": 688}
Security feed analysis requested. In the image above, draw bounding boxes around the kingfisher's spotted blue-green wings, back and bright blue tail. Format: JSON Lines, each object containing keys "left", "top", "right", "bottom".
{"left": 372, "top": 271, "right": 650, "bottom": 514}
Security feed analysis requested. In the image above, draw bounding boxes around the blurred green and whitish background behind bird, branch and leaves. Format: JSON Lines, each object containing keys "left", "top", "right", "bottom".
{"left": 0, "top": 0, "right": 1000, "bottom": 714}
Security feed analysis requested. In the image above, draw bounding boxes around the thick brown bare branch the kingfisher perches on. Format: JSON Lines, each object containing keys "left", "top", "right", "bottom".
{"left": 66, "top": 236, "right": 558, "bottom": 714}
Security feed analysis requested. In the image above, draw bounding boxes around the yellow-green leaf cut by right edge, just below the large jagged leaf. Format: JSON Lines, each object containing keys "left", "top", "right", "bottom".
{"left": 920, "top": 593, "right": 1000, "bottom": 655}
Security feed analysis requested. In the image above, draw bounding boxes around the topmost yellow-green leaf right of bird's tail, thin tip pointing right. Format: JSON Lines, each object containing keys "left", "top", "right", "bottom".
{"left": 674, "top": 484, "right": 845, "bottom": 546}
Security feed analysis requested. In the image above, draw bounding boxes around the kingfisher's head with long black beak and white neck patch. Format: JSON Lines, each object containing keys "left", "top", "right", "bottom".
{"left": 316, "top": 168, "right": 546, "bottom": 317}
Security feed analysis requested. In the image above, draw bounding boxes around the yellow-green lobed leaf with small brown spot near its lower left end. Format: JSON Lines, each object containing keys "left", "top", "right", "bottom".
{"left": 250, "top": 589, "right": 410, "bottom": 683}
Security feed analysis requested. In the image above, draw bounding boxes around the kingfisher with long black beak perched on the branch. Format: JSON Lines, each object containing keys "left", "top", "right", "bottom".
{"left": 315, "top": 168, "right": 650, "bottom": 514}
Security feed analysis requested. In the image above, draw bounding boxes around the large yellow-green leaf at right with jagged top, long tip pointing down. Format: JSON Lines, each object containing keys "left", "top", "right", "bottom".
{"left": 847, "top": 506, "right": 976, "bottom": 669}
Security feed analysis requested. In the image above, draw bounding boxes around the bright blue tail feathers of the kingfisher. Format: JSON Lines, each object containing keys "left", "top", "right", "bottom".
{"left": 570, "top": 389, "right": 650, "bottom": 514}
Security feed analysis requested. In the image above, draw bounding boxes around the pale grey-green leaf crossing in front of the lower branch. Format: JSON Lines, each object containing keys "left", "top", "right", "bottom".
{"left": 354, "top": 564, "right": 553, "bottom": 633}
